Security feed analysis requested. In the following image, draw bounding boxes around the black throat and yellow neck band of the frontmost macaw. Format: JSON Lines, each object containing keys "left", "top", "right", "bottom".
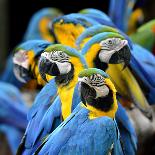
{"left": 83, "top": 89, "right": 118, "bottom": 119}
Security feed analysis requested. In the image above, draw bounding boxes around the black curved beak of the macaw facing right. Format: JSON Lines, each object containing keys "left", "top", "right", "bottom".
{"left": 109, "top": 45, "right": 131, "bottom": 69}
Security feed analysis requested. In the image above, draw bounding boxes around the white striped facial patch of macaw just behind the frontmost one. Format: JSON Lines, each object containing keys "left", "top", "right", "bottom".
{"left": 41, "top": 51, "right": 71, "bottom": 75}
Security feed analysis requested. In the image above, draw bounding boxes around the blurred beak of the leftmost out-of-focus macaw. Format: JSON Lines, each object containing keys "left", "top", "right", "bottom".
{"left": 13, "top": 64, "right": 31, "bottom": 83}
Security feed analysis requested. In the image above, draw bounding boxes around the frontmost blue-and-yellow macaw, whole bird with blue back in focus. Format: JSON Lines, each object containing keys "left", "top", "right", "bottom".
{"left": 35, "top": 68, "right": 124, "bottom": 155}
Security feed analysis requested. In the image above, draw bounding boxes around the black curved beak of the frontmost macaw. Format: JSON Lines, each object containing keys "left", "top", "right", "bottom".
{"left": 79, "top": 82, "right": 96, "bottom": 106}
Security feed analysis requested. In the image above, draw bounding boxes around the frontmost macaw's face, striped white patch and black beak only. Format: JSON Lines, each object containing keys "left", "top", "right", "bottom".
{"left": 78, "top": 74, "right": 110, "bottom": 104}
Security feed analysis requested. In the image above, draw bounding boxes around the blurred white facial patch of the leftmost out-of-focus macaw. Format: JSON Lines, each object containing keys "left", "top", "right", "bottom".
{"left": 13, "top": 50, "right": 29, "bottom": 69}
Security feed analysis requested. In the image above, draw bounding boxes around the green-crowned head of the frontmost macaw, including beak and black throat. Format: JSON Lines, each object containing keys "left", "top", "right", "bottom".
{"left": 78, "top": 68, "right": 117, "bottom": 116}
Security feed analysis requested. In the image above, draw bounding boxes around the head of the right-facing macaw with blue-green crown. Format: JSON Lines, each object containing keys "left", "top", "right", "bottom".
{"left": 81, "top": 32, "right": 131, "bottom": 70}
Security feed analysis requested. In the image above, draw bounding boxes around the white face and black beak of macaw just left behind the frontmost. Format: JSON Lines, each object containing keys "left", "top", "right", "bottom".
{"left": 39, "top": 51, "right": 73, "bottom": 82}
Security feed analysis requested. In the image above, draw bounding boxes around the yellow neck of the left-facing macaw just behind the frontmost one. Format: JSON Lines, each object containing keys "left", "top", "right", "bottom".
{"left": 58, "top": 59, "right": 84, "bottom": 120}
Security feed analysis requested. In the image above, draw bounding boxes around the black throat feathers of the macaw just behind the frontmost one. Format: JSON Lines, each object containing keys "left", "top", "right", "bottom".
{"left": 55, "top": 64, "right": 74, "bottom": 86}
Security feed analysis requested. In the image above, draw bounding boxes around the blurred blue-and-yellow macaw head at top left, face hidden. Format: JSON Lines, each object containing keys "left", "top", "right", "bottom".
{"left": 24, "top": 8, "right": 62, "bottom": 42}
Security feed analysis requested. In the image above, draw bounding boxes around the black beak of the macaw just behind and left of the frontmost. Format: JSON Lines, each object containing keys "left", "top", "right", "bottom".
{"left": 39, "top": 57, "right": 60, "bottom": 82}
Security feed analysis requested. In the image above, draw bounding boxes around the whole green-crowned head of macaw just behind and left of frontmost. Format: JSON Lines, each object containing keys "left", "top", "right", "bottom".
{"left": 39, "top": 44, "right": 87, "bottom": 85}
